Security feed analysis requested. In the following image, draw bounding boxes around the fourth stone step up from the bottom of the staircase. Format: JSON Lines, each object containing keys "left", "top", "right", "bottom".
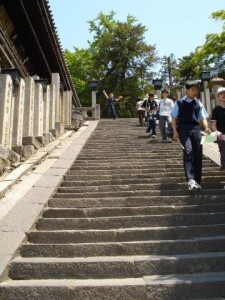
{"left": 28, "top": 224, "right": 225, "bottom": 244}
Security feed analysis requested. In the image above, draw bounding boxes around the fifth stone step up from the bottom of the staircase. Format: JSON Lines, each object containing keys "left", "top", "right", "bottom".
{"left": 36, "top": 212, "right": 225, "bottom": 230}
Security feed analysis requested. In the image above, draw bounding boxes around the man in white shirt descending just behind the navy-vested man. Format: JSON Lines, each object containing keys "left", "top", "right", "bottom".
{"left": 159, "top": 89, "right": 174, "bottom": 143}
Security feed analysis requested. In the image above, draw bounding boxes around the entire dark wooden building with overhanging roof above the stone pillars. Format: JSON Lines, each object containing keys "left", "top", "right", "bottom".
{"left": 0, "top": 0, "right": 80, "bottom": 107}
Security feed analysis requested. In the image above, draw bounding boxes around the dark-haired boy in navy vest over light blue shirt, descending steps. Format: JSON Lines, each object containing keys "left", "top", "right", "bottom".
{"left": 171, "top": 81, "right": 210, "bottom": 190}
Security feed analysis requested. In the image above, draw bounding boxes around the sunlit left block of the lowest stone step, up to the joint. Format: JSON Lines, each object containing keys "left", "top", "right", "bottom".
{"left": 0, "top": 278, "right": 148, "bottom": 300}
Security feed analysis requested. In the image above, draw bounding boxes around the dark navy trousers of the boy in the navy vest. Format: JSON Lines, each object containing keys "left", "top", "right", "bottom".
{"left": 178, "top": 124, "right": 202, "bottom": 184}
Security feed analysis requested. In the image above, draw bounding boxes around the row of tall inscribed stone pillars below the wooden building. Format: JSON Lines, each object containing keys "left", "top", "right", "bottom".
{"left": 0, "top": 73, "right": 72, "bottom": 158}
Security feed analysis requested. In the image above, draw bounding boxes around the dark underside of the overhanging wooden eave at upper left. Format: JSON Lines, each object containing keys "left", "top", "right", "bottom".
{"left": 0, "top": 0, "right": 80, "bottom": 107}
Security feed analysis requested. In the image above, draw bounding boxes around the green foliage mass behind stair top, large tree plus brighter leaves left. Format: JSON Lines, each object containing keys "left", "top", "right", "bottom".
{"left": 65, "top": 11, "right": 157, "bottom": 116}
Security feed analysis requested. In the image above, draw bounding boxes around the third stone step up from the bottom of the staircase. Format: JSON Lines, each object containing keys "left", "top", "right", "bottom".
{"left": 20, "top": 236, "right": 225, "bottom": 257}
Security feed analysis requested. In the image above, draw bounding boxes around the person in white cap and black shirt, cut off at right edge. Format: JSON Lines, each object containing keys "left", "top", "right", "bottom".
{"left": 210, "top": 87, "right": 225, "bottom": 170}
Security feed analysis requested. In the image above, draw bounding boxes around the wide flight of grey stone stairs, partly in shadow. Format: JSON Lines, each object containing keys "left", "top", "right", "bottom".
{"left": 0, "top": 119, "right": 225, "bottom": 300}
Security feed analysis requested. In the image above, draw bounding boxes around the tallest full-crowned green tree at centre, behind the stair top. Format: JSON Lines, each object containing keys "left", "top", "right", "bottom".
{"left": 89, "top": 12, "right": 157, "bottom": 116}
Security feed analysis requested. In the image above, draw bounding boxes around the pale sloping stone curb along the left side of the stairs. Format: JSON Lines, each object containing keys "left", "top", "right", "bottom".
{"left": 0, "top": 121, "right": 99, "bottom": 282}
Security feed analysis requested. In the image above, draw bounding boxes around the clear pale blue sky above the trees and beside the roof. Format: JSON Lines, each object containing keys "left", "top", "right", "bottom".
{"left": 49, "top": 0, "right": 225, "bottom": 58}
